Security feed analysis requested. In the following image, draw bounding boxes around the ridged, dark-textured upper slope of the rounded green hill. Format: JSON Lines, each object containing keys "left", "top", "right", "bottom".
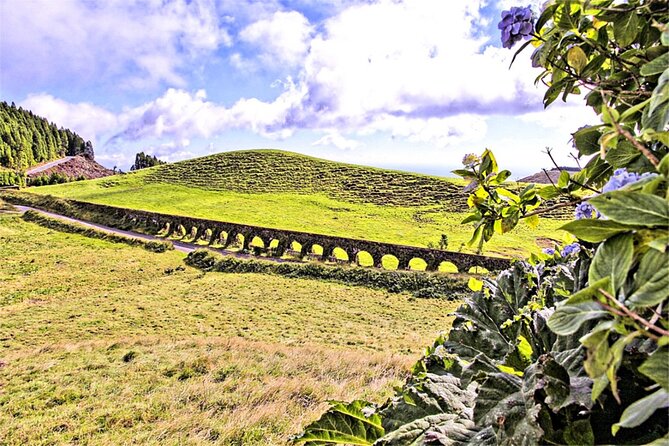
{"left": 144, "top": 150, "right": 467, "bottom": 211}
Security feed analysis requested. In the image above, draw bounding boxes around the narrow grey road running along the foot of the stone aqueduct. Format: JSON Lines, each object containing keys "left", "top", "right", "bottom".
{"left": 14, "top": 205, "right": 304, "bottom": 263}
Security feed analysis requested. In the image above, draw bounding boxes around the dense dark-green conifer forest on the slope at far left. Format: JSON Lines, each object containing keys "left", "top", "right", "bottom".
{"left": 0, "top": 101, "right": 94, "bottom": 170}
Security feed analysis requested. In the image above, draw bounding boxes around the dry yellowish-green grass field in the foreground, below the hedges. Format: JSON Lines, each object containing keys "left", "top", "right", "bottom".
{"left": 0, "top": 214, "right": 455, "bottom": 445}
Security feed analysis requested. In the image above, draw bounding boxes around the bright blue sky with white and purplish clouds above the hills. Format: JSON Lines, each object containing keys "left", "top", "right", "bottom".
{"left": 0, "top": 0, "right": 595, "bottom": 177}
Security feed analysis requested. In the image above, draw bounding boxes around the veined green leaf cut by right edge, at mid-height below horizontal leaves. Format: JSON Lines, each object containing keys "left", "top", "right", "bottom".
{"left": 627, "top": 249, "right": 669, "bottom": 308}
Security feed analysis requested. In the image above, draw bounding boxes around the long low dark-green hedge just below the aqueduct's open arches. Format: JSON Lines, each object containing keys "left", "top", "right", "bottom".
{"left": 185, "top": 249, "right": 467, "bottom": 300}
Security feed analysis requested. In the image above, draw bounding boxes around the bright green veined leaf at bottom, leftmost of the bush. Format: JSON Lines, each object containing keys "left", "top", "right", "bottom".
{"left": 292, "top": 400, "right": 385, "bottom": 446}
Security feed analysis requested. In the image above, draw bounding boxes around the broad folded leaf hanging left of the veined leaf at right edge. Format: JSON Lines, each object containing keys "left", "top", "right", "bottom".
{"left": 588, "top": 233, "right": 634, "bottom": 294}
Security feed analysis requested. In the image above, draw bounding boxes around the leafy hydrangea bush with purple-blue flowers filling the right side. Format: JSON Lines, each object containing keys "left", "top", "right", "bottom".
{"left": 298, "top": 0, "right": 669, "bottom": 445}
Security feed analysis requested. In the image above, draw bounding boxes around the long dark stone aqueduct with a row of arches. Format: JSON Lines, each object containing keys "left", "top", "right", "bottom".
{"left": 7, "top": 196, "right": 510, "bottom": 272}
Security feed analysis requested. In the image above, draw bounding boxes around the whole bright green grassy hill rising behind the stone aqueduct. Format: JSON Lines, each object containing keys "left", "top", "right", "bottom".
{"left": 35, "top": 150, "right": 561, "bottom": 256}
